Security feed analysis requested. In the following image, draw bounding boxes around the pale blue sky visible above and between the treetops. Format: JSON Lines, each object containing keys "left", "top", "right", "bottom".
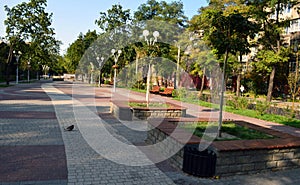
{"left": 0, "top": 0, "right": 207, "bottom": 53}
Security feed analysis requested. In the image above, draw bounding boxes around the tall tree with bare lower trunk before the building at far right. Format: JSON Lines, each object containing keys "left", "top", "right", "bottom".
{"left": 247, "top": 0, "right": 297, "bottom": 102}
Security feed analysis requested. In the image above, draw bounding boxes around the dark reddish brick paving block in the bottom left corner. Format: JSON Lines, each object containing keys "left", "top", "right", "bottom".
{"left": 0, "top": 145, "right": 67, "bottom": 182}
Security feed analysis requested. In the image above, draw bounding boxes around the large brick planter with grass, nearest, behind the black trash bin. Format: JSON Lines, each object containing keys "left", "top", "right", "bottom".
{"left": 147, "top": 118, "right": 300, "bottom": 176}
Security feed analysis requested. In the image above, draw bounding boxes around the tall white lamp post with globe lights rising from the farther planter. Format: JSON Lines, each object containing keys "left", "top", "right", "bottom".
{"left": 143, "top": 30, "right": 159, "bottom": 104}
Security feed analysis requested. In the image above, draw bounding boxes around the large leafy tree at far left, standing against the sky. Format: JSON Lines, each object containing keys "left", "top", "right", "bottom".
{"left": 4, "top": 0, "right": 60, "bottom": 84}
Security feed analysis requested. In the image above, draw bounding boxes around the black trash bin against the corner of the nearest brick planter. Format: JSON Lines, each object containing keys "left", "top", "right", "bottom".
{"left": 182, "top": 147, "right": 217, "bottom": 177}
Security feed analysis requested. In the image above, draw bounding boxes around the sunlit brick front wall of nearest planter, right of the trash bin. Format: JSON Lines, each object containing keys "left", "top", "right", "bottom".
{"left": 216, "top": 147, "right": 300, "bottom": 176}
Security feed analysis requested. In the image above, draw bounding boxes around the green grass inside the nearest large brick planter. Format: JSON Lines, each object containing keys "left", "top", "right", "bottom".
{"left": 183, "top": 122, "right": 275, "bottom": 140}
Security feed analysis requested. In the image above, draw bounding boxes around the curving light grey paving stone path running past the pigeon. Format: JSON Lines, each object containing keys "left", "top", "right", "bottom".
{"left": 45, "top": 86, "right": 173, "bottom": 184}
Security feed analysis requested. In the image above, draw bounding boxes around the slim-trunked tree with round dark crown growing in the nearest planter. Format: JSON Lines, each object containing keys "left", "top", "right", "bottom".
{"left": 191, "top": 0, "right": 254, "bottom": 136}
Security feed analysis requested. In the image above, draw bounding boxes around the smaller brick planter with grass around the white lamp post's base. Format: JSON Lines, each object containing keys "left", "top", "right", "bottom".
{"left": 111, "top": 101, "right": 186, "bottom": 121}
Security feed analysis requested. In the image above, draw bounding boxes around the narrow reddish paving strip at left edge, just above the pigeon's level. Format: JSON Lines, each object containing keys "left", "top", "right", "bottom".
{"left": 0, "top": 111, "right": 56, "bottom": 119}
